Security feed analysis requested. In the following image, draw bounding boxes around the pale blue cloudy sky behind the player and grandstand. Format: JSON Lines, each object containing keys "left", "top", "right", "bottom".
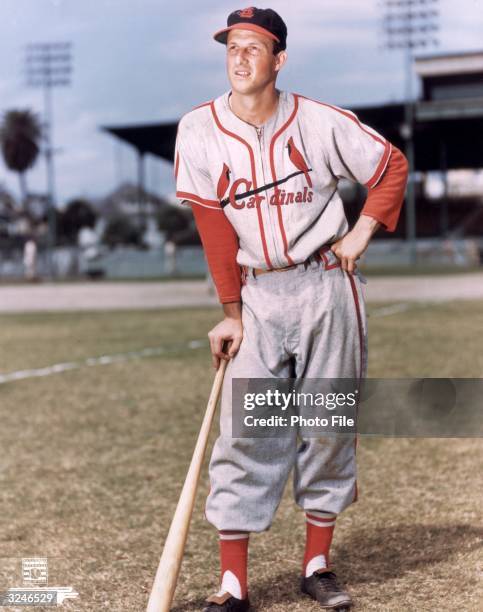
{"left": 0, "top": 0, "right": 483, "bottom": 205}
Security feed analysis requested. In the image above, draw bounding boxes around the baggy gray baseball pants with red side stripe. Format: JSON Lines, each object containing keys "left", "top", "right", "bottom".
{"left": 205, "top": 251, "right": 367, "bottom": 532}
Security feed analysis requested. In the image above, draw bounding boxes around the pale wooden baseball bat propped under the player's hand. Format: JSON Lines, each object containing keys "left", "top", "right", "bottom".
{"left": 146, "top": 359, "right": 227, "bottom": 612}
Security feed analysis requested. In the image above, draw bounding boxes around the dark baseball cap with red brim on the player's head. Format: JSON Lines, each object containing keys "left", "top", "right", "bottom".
{"left": 213, "top": 6, "right": 287, "bottom": 49}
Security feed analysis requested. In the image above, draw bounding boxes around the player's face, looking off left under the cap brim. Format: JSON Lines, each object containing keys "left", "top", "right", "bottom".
{"left": 226, "top": 30, "right": 286, "bottom": 95}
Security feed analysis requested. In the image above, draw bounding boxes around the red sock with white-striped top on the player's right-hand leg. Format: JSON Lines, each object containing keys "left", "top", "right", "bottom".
{"left": 302, "top": 511, "right": 336, "bottom": 577}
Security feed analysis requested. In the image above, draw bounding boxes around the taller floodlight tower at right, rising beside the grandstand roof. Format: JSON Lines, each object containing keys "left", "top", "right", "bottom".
{"left": 381, "top": 0, "right": 439, "bottom": 264}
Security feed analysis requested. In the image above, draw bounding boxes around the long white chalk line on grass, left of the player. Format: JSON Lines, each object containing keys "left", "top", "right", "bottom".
{"left": 0, "top": 340, "right": 208, "bottom": 385}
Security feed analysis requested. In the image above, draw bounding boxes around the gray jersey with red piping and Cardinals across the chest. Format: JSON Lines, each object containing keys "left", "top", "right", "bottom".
{"left": 175, "top": 91, "right": 391, "bottom": 269}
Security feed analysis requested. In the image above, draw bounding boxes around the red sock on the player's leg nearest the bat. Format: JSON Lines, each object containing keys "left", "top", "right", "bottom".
{"left": 218, "top": 531, "right": 249, "bottom": 599}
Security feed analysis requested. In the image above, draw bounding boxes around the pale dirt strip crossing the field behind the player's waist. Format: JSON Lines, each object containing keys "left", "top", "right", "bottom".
{"left": 0, "top": 272, "right": 483, "bottom": 313}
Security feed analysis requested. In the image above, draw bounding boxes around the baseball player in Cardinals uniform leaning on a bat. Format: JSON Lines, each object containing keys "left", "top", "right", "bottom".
{"left": 175, "top": 7, "right": 407, "bottom": 612}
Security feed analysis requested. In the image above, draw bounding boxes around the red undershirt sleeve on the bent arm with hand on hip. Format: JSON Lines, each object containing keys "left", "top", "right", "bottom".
{"left": 361, "top": 145, "right": 408, "bottom": 232}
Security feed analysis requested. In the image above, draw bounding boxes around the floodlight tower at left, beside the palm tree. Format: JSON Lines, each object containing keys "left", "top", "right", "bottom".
{"left": 26, "top": 42, "right": 72, "bottom": 276}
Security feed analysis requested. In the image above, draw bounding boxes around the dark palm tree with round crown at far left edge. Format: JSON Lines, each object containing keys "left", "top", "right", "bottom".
{"left": 0, "top": 110, "right": 42, "bottom": 208}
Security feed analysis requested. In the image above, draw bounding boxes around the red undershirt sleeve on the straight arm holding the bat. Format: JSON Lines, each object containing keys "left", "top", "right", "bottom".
{"left": 191, "top": 204, "right": 241, "bottom": 304}
